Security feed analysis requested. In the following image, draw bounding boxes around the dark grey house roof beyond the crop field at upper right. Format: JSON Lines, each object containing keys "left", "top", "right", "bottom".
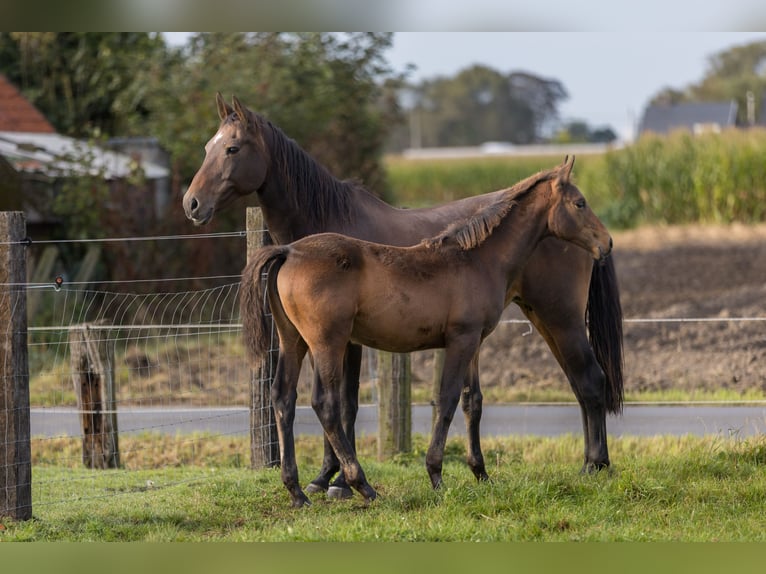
{"left": 639, "top": 100, "right": 737, "bottom": 134}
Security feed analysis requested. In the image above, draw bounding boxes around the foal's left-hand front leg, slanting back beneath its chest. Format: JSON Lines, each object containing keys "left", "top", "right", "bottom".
{"left": 426, "top": 334, "right": 479, "bottom": 488}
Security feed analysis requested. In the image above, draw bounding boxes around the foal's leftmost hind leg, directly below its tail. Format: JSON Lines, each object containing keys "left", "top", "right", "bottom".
{"left": 271, "top": 338, "right": 311, "bottom": 507}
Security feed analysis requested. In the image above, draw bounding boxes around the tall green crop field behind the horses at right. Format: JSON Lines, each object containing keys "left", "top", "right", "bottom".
{"left": 386, "top": 129, "right": 766, "bottom": 228}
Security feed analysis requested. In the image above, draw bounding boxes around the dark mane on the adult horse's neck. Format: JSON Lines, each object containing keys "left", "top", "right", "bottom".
{"left": 253, "top": 114, "right": 362, "bottom": 230}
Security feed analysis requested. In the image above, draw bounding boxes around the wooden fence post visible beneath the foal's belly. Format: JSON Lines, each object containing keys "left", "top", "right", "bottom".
{"left": 378, "top": 351, "right": 412, "bottom": 460}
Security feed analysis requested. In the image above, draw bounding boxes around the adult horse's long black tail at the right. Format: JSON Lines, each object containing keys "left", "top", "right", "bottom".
{"left": 586, "top": 257, "right": 623, "bottom": 414}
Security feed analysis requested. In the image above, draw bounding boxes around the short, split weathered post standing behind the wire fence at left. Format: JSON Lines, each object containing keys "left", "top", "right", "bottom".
{"left": 69, "top": 324, "right": 120, "bottom": 468}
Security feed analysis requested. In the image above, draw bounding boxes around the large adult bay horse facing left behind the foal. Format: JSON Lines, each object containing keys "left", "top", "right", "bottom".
{"left": 183, "top": 94, "right": 623, "bottom": 500}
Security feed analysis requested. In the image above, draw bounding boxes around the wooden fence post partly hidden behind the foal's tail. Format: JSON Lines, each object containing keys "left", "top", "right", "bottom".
{"left": 246, "top": 207, "right": 279, "bottom": 468}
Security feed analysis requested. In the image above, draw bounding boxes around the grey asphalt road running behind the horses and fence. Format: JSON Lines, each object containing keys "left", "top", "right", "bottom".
{"left": 31, "top": 404, "right": 766, "bottom": 437}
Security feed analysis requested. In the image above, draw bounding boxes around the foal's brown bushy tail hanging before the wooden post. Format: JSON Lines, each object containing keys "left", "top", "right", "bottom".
{"left": 239, "top": 245, "right": 289, "bottom": 365}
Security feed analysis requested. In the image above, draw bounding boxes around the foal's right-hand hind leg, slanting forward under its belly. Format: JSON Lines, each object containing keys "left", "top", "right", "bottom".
{"left": 311, "top": 347, "right": 377, "bottom": 502}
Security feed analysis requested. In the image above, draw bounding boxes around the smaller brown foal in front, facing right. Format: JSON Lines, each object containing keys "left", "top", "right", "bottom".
{"left": 240, "top": 161, "right": 612, "bottom": 506}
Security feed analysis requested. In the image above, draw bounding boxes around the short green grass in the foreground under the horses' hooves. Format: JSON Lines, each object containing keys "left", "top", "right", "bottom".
{"left": 6, "top": 436, "right": 766, "bottom": 542}
